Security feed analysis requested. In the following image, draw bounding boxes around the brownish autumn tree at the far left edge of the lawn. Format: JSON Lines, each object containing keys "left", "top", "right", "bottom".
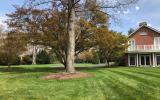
{"left": 0, "top": 32, "right": 26, "bottom": 67}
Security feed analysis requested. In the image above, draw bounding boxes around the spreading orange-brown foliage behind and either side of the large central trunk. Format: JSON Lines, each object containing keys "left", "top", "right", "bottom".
{"left": 8, "top": 3, "right": 102, "bottom": 70}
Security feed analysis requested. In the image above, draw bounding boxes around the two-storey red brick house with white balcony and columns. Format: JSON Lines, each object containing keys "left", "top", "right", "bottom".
{"left": 127, "top": 22, "right": 160, "bottom": 67}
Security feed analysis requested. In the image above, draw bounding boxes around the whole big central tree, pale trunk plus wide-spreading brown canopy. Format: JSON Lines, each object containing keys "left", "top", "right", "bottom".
{"left": 7, "top": 0, "right": 138, "bottom": 73}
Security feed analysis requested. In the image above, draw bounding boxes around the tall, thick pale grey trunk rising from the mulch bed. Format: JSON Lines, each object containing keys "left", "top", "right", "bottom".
{"left": 66, "top": 0, "right": 76, "bottom": 73}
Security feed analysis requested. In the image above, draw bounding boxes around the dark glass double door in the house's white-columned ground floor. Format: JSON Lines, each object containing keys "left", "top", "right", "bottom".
{"left": 140, "top": 55, "right": 151, "bottom": 66}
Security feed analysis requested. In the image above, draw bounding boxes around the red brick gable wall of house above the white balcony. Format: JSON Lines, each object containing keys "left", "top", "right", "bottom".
{"left": 129, "top": 26, "right": 160, "bottom": 45}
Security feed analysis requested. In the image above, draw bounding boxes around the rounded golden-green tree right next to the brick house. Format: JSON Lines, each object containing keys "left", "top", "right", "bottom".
{"left": 96, "top": 28, "right": 128, "bottom": 66}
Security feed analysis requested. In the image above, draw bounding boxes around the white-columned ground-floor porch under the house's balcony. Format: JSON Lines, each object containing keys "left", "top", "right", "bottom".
{"left": 128, "top": 52, "right": 160, "bottom": 67}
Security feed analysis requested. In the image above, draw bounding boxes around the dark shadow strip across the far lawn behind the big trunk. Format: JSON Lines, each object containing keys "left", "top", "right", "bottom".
{"left": 0, "top": 66, "right": 105, "bottom": 73}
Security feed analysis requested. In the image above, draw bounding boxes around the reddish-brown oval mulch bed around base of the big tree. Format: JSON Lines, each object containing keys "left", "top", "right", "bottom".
{"left": 44, "top": 72, "right": 93, "bottom": 80}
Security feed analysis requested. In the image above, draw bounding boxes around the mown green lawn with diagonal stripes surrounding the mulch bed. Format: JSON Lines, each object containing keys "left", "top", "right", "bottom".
{"left": 0, "top": 64, "right": 160, "bottom": 100}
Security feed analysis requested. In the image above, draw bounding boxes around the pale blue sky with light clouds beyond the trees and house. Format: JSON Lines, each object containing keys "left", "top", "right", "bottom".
{"left": 0, "top": 0, "right": 160, "bottom": 34}
